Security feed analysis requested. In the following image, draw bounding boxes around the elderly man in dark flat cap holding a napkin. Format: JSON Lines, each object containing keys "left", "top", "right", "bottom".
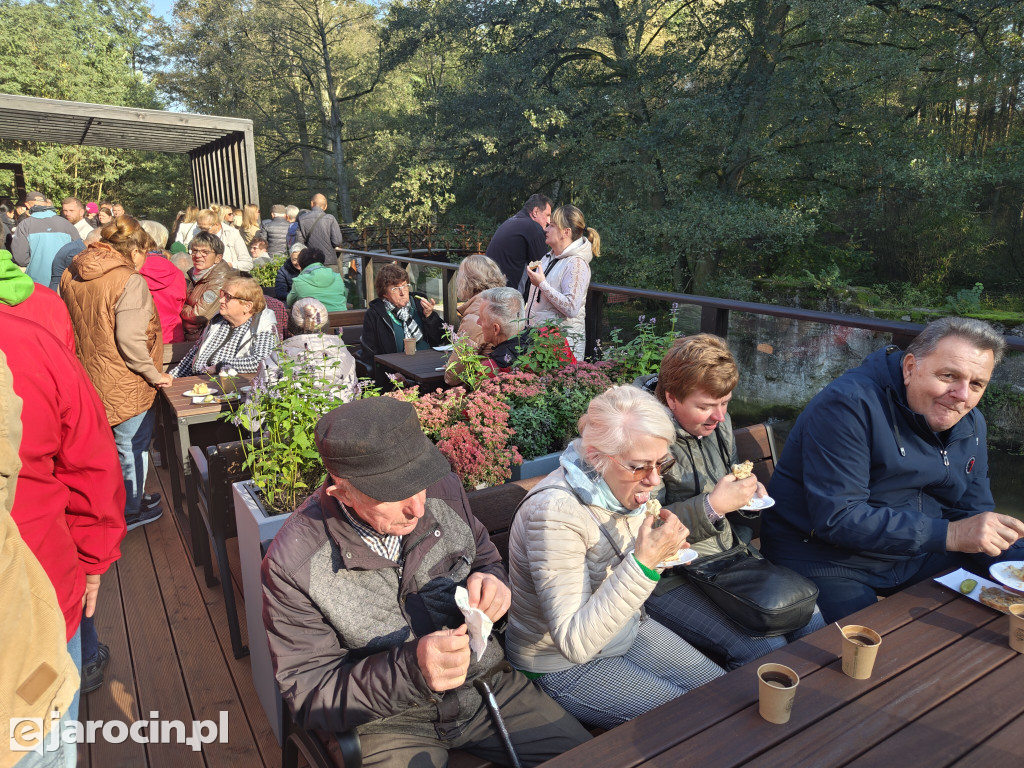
{"left": 263, "top": 397, "right": 590, "bottom": 768}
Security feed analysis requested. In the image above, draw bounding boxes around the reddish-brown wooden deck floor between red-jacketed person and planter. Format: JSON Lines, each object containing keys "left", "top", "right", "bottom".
{"left": 79, "top": 454, "right": 281, "bottom": 768}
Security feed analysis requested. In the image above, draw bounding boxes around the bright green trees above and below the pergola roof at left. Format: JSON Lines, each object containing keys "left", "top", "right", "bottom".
{"left": 0, "top": 0, "right": 191, "bottom": 223}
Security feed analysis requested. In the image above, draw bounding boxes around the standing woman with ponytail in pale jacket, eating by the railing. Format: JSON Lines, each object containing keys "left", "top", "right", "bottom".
{"left": 526, "top": 205, "right": 601, "bottom": 360}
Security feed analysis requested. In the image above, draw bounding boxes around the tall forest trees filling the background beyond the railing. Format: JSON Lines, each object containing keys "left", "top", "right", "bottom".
{"left": 0, "top": 0, "right": 1024, "bottom": 296}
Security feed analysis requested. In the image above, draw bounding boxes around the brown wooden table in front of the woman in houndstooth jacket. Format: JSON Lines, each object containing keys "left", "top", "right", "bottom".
{"left": 160, "top": 374, "right": 253, "bottom": 571}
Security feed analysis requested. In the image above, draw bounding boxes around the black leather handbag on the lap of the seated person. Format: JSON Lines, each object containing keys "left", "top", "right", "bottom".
{"left": 676, "top": 543, "right": 818, "bottom": 637}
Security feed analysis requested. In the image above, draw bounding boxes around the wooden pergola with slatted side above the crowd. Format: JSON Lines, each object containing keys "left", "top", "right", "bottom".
{"left": 0, "top": 93, "right": 259, "bottom": 208}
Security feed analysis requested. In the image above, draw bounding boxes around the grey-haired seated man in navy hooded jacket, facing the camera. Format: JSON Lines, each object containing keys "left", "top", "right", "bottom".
{"left": 761, "top": 317, "right": 1024, "bottom": 622}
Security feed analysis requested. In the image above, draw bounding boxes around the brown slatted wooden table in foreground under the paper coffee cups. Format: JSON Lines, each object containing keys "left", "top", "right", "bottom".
{"left": 545, "top": 581, "right": 1024, "bottom": 768}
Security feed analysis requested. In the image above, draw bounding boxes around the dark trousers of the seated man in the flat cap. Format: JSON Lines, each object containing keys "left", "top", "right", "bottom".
{"left": 344, "top": 672, "right": 591, "bottom": 768}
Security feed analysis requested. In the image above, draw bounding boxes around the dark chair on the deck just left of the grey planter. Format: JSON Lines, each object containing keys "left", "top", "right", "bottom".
{"left": 188, "top": 440, "right": 252, "bottom": 658}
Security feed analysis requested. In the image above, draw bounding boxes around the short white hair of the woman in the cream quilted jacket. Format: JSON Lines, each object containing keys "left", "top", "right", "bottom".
{"left": 580, "top": 384, "right": 676, "bottom": 475}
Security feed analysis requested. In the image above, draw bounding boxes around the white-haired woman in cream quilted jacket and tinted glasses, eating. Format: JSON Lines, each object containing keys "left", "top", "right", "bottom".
{"left": 505, "top": 386, "right": 724, "bottom": 728}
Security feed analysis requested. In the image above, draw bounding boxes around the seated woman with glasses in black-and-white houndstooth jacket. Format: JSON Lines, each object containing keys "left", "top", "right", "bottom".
{"left": 171, "top": 276, "right": 280, "bottom": 378}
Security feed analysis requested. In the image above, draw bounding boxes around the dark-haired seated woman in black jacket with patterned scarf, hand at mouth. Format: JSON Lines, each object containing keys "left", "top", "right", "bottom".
{"left": 359, "top": 264, "right": 443, "bottom": 386}
